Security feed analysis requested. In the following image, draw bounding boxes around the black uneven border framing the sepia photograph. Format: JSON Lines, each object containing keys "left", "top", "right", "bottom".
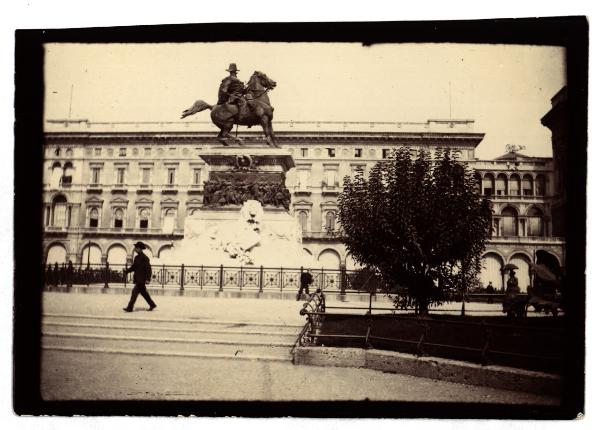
{"left": 13, "top": 17, "right": 589, "bottom": 419}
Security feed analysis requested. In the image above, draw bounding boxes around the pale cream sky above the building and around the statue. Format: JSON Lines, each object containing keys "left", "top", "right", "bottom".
{"left": 45, "top": 42, "right": 566, "bottom": 158}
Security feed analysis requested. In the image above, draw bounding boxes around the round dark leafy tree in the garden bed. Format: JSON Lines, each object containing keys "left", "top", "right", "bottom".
{"left": 338, "top": 147, "right": 492, "bottom": 314}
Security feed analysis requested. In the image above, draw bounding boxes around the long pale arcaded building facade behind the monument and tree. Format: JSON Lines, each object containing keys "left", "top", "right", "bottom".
{"left": 43, "top": 120, "right": 564, "bottom": 288}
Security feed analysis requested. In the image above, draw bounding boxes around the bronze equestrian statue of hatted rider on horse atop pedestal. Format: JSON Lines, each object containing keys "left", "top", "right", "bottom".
{"left": 181, "top": 63, "right": 279, "bottom": 148}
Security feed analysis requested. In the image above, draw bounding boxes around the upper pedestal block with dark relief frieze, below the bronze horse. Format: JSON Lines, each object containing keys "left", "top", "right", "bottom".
{"left": 200, "top": 147, "right": 294, "bottom": 210}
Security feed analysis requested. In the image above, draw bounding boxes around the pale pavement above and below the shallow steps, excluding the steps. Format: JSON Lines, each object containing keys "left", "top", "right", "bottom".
{"left": 41, "top": 292, "right": 558, "bottom": 405}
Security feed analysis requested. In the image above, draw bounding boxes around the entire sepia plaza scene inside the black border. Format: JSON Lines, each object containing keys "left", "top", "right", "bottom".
{"left": 15, "top": 21, "right": 583, "bottom": 416}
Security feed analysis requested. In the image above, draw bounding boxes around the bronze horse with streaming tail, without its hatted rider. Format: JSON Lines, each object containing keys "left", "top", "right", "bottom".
{"left": 181, "top": 71, "right": 279, "bottom": 148}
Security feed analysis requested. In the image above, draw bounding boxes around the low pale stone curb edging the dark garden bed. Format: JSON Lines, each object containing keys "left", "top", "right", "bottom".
{"left": 294, "top": 347, "right": 561, "bottom": 396}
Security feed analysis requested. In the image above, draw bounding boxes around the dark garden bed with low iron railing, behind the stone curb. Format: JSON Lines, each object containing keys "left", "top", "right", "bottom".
{"left": 294, "top": 310, "right": 565, "bottom": 373}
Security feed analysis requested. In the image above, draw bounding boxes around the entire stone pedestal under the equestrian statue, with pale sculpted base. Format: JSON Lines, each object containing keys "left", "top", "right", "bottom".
{"left": 150, "top": 146, "right": 316, "bottom": 268}
